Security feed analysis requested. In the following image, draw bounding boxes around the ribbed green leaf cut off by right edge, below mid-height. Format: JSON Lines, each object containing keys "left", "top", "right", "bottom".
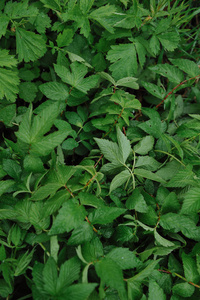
{"left": 181, "top": 187, "right": 200, "bottom": 215}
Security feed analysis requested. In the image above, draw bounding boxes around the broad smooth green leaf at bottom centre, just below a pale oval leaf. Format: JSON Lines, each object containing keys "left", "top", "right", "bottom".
{"left": 95, "top": 258, "right": 126, "bottom": 299}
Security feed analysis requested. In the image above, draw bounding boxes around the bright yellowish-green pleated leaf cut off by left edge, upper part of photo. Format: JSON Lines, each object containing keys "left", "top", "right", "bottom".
{"left": 0, "top": 68, "right": 19, "bottom": 102}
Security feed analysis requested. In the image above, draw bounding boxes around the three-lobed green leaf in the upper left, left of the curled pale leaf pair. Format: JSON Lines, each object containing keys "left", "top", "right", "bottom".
{"left": 54, "top": 61, "right": 99, "bottom": 94}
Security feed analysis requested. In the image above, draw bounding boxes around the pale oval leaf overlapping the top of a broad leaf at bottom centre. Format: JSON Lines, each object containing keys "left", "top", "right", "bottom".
{"left": 106, "top": 248, "right": 141, "bottom": 270}
